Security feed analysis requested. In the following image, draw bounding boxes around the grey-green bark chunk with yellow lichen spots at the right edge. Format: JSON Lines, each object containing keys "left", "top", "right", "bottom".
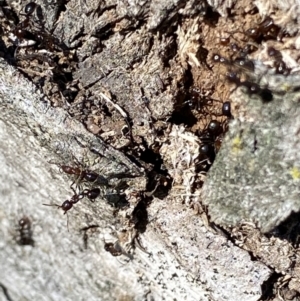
{"left": 203, "top": 66, "right": 300, "bottom": 232}
